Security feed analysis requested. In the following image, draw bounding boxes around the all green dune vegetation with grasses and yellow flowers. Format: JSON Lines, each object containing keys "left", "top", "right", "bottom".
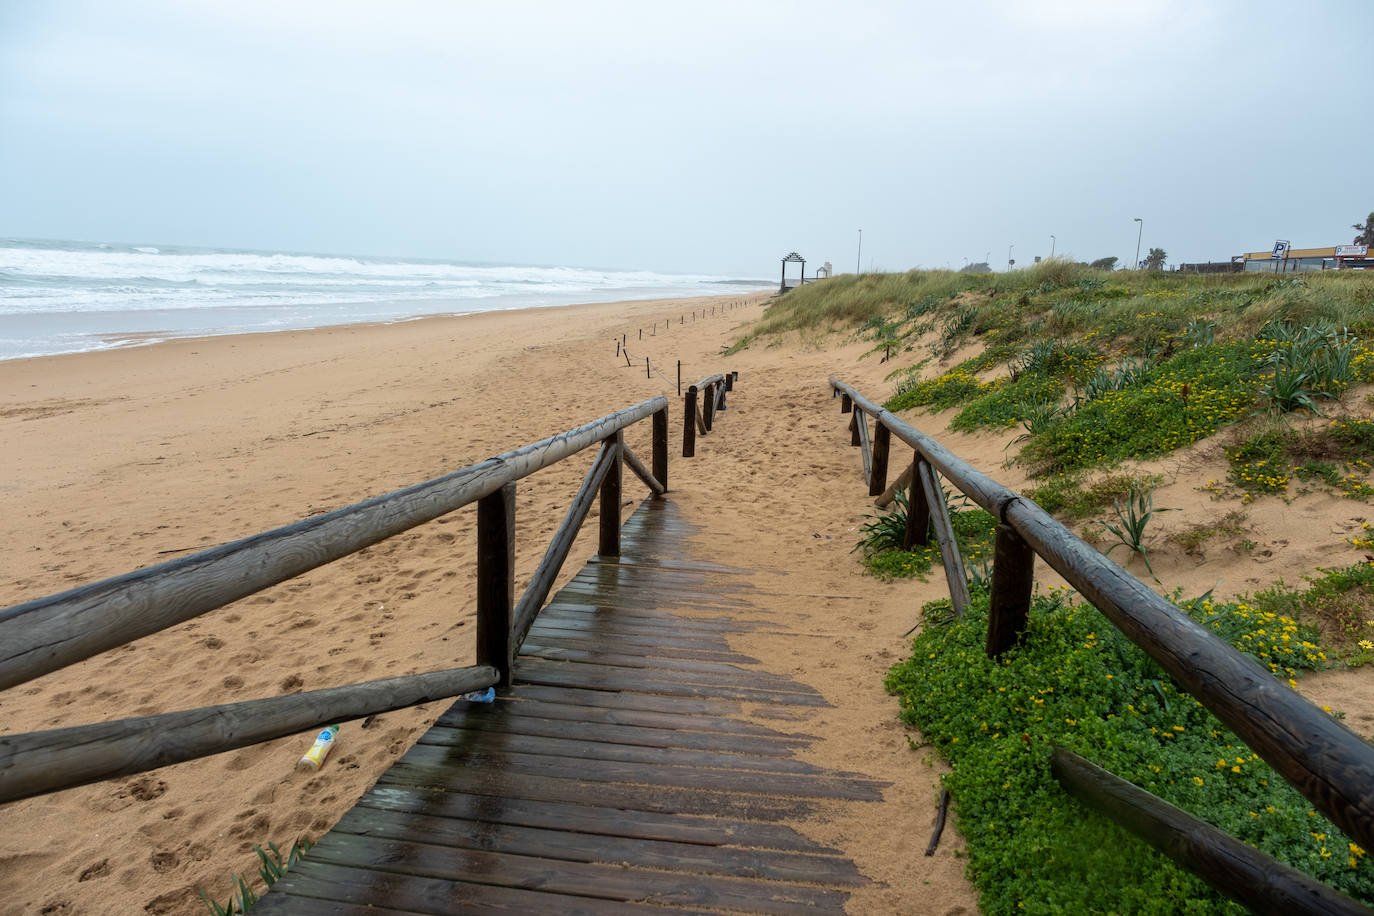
{"left": 735, "top": 261, "right": 1374, "bottom": 913}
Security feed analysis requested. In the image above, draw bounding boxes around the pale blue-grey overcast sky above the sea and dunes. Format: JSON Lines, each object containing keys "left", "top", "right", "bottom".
{"left": 0, "top": 0, "right": 1374, "bottom": 277}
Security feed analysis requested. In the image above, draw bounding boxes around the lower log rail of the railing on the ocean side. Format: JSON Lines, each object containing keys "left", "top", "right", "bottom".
{"left": 0, "top": 666, "right": 497, "bottom": 802}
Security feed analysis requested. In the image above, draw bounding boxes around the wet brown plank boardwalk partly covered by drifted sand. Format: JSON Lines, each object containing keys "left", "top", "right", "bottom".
{"left": 253, "top": 500, "right": 882, "bottom": 913}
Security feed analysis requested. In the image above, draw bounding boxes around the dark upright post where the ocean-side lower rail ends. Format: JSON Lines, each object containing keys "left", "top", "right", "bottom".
{"left": 477, "top": 483, "right": 515, "bottom": 687}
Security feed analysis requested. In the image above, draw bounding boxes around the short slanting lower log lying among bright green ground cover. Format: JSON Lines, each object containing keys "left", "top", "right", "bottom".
{"left": 1050, "top": 747, "right": 1374, "bottom": 916}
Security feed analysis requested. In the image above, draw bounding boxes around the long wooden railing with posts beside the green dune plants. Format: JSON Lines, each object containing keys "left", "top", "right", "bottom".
{"left": 830, "top": 378, "right": 1374, "bottom": 915}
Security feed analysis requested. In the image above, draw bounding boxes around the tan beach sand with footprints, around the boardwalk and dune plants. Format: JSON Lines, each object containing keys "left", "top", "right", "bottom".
{"left": 0, "top": 289, "right": 1374, "bottom": 915}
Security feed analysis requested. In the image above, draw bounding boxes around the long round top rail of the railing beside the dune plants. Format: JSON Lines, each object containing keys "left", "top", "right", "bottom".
{"left": 830, "top": 379, "right": 1374, "bottom": 849}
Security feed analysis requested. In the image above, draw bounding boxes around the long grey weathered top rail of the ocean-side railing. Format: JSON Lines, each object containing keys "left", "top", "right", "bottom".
{"left": 0, "top": 397, "right": 668, "bottom": 689}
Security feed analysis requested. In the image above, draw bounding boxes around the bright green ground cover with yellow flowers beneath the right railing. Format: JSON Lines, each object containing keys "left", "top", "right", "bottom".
{"left": 886, "top": 592, "right": 1374, "bottom": 915}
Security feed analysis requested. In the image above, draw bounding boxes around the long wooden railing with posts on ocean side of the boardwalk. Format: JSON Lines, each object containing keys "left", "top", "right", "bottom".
{"left": 0, "top": 397, "right": 668, "bottom": 802}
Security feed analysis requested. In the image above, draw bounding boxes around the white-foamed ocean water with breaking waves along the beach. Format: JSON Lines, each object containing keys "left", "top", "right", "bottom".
{"left": 0, "top": 239, "right": 774, "bottom": 360}
